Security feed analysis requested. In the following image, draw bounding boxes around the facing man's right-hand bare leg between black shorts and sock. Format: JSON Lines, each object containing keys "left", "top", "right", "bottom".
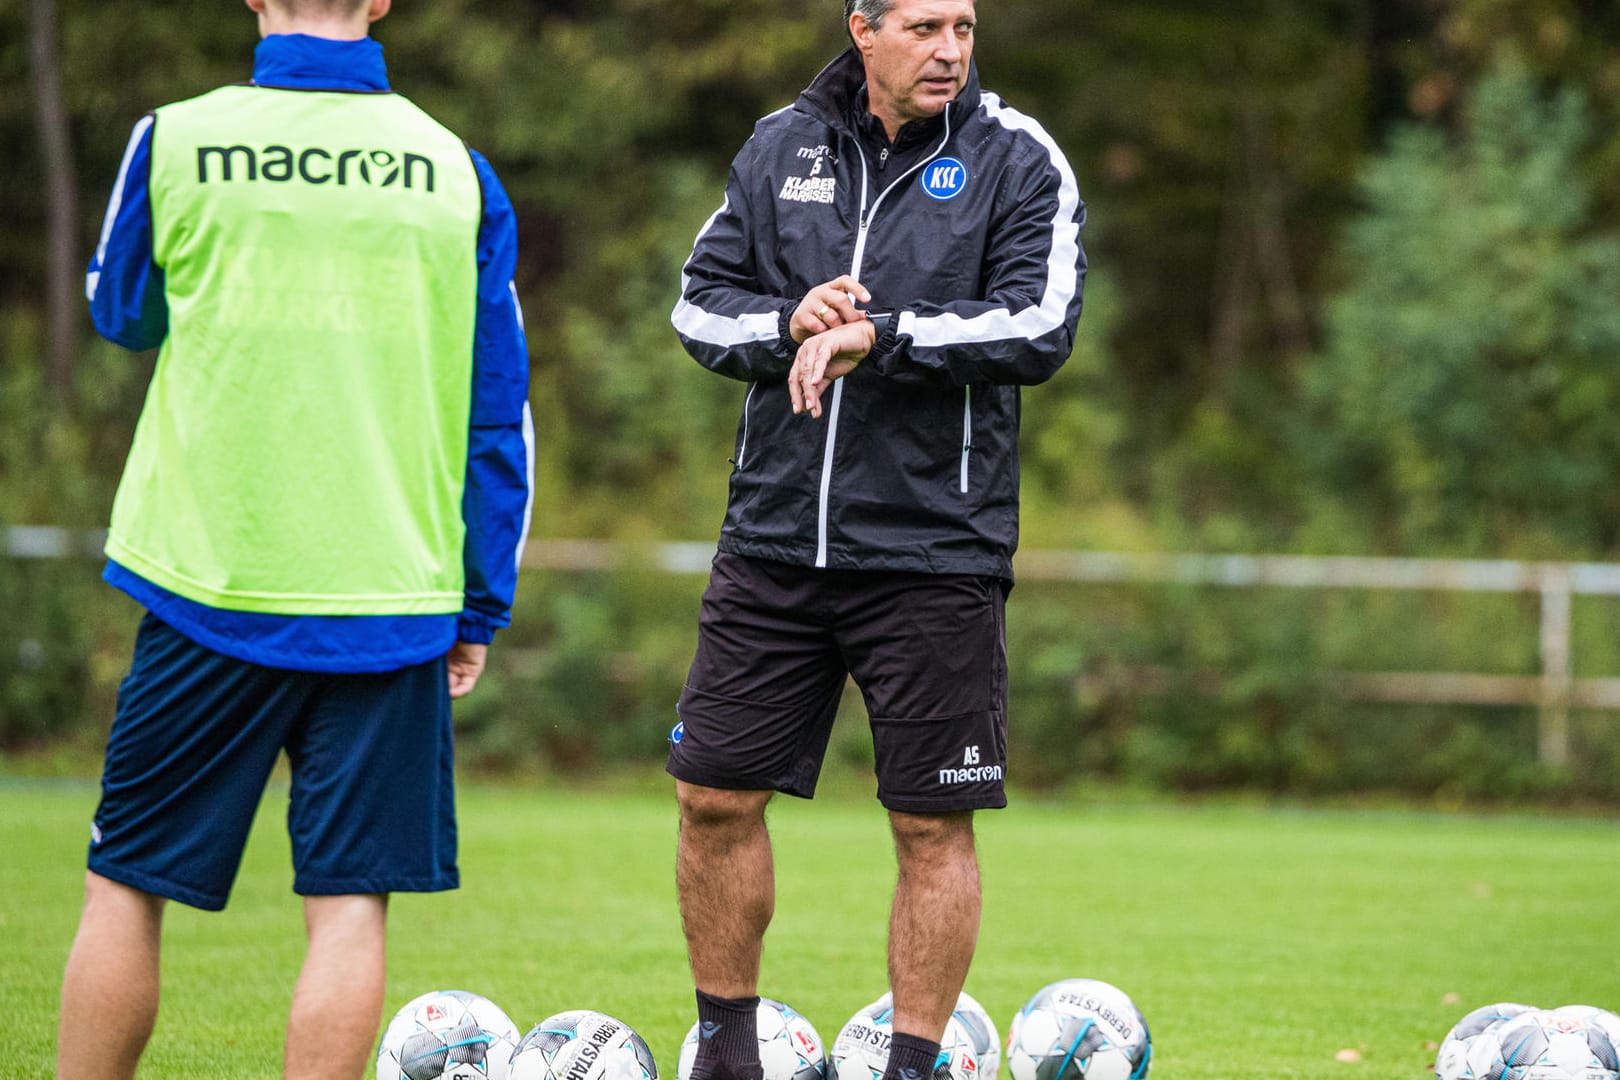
{"left": 889, "top": 811, "right": 980, "bottom": 1042}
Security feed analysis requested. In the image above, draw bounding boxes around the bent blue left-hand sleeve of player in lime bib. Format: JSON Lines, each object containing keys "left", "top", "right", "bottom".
{"left": 84, "top": 113, "right": 168, "bottom": 350}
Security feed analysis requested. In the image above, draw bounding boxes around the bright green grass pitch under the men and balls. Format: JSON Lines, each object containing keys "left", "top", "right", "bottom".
{"left": 0, "top": 780, "right": 1620, "bottom": 1080}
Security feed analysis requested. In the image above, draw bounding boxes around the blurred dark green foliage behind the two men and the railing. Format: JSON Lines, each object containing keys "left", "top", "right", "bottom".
{"left": 9, "top": 0, "right": 1620, "bottom": 800}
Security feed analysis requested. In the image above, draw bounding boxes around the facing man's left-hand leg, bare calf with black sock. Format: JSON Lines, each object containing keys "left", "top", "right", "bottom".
{"left": 676, "top": 780, "right": 776, "bottom": 1080}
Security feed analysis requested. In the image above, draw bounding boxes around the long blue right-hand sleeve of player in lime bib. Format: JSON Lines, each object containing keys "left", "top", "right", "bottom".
{"left": 457, "top": 151, "right": 535, "bottom": 644}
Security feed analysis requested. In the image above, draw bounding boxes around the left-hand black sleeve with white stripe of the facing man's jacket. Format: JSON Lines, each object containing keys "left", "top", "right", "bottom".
{"left": 669, "top": 139, "right": 799, "bottom": 381}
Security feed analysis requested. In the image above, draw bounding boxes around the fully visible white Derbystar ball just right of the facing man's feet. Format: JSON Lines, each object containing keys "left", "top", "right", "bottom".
{"left": 1008, "top": 978, "right": 1153, "bottom": 1080}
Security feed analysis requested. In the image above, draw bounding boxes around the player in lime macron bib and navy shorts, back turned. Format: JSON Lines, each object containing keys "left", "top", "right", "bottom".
{"left": 57, "top": 0, "right": 533, "bottom": 1080}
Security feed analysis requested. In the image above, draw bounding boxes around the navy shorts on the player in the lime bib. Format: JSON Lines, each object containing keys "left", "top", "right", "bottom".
{"left": 89, "top": 614, "right": 460, "bottom": 912}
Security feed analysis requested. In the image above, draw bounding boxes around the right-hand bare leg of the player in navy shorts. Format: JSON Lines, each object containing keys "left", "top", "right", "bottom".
{"left": 284, "top": 895, "right": 389, "bottom": 1080}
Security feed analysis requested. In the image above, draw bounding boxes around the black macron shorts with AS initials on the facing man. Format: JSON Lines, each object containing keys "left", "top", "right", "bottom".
{"left": 667, "top": 552, "right": 1008, "bottom": 813}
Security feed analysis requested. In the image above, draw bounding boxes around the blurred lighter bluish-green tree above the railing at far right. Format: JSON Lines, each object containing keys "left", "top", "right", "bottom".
{"left": 1307, "top": 63, "right": 1620, "bottom": 555}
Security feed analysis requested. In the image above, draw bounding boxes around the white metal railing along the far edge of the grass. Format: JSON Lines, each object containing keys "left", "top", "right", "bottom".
{"left": 12, "top": 526, "right": 1620, "bottom": 764}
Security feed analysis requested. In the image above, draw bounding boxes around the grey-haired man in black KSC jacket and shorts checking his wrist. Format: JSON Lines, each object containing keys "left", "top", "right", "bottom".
{"left": 667, "top": 0, "right": 1085, "bottom": 1080}
